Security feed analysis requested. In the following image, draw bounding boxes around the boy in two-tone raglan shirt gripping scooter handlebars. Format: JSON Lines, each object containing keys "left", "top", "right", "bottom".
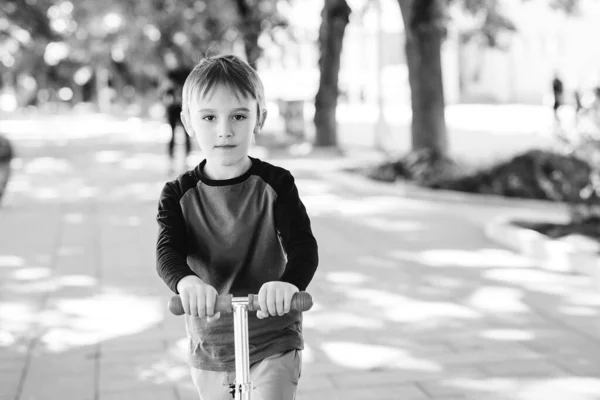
{"left": 156, "top": 56, "right": 318, "bottom": 400}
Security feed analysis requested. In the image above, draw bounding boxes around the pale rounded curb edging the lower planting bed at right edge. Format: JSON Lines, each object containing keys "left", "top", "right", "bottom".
{"left": 484, "top": 213, "right": 600, "bottom": 290}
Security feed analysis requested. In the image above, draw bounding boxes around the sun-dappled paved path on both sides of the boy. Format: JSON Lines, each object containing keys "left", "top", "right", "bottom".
{"left": 0, "top": 116, "right": 600, "bottom": 400}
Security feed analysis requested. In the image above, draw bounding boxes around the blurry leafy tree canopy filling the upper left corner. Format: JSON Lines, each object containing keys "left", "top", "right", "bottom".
{"left": 0, "top": 0, "right": 285, "bottom": 96}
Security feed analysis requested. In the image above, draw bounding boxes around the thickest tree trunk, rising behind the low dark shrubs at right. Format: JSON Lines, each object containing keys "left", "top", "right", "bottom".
{"left": 398, "top": 0, "right": 448, "bottom": 156}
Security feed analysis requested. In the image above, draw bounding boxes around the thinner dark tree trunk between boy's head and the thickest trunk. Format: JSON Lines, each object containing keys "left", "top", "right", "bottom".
{"left": 314, "top": 0, "right": 351, "bottom": 147}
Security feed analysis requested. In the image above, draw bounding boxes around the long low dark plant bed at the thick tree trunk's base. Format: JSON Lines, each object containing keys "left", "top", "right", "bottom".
{"left": 367, "top": 147, "right": 600, "bottom": 220}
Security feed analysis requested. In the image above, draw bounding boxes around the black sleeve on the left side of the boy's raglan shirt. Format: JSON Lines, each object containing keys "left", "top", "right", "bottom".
{"left": 156, "top": 183, "right": 194, "bottom": 293}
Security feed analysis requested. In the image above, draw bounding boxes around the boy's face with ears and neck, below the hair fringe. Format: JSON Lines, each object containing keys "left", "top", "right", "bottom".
{"left": 181, "top": 85, "right": 259, "bottom": 168}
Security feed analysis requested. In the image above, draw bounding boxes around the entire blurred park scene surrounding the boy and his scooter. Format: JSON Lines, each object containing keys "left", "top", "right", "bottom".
{"left": 0, "top": 0, "right": 600, "bottom": 400}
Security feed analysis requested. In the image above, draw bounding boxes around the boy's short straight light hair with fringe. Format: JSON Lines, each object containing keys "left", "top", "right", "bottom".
{"left": 182, "top": 54, "right": 266, "bottom": 124}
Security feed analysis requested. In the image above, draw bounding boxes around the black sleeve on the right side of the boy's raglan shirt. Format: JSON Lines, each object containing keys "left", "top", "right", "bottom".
{"left": 275, "top": 171, "right": 319, "bottom": 290}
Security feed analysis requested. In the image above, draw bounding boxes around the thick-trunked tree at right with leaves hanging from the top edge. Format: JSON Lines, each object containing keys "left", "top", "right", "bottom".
{"left": 398, "top": 0, "right": 579, "bottom": 161}
